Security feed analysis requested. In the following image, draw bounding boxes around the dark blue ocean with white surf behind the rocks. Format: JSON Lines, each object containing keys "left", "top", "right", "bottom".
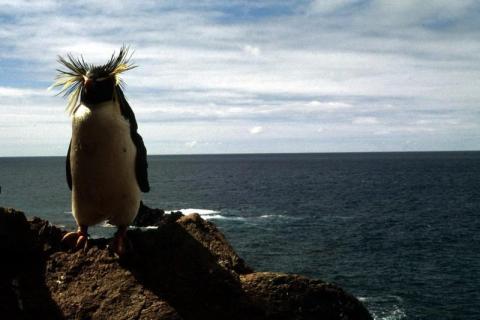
{"left": 0, "top": 152, "right": 480, "bottom": 320}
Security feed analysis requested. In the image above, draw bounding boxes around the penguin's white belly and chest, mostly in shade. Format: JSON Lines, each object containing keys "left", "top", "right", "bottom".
{"left": 70, "top": 102, "right": 140, "bottom": 226}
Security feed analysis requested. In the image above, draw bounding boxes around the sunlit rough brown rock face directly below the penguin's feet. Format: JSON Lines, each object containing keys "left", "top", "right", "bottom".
{"left": 45, "top": 247, "right": 182, "bottom": 320}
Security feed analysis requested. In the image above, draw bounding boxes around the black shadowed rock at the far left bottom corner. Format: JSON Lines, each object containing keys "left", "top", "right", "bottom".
{"left": 0, "top": 208, "right": 63, "bottom": 319}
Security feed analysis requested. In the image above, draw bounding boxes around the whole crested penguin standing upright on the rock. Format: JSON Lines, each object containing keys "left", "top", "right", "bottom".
{"left": 52, "top": 46, "right": 150, "bottom": 256}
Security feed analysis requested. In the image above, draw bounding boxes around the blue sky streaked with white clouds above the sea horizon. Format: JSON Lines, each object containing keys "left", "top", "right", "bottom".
{"left": 0, "top": 0, "right": 480, "bottom": 156}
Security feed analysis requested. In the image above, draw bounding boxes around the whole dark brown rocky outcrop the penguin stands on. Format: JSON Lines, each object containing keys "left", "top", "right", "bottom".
{"left": 0, "top": 208, "right": 371, "bottom": 320}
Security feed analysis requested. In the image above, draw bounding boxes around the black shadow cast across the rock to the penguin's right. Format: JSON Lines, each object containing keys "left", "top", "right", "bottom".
{"left": 122, "top": 215, "right": 262, "bottom": 319}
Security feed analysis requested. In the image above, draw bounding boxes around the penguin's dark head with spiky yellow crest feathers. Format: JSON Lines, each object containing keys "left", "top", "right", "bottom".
{"left": 51, "top": 46, "right": 136, "bottom": 114}
